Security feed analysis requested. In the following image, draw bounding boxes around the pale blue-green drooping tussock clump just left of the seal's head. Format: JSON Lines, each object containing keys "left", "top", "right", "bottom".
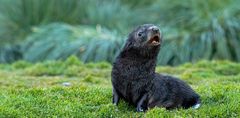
{"left": 22, "top": 23, "right": 123, "bottom": 62}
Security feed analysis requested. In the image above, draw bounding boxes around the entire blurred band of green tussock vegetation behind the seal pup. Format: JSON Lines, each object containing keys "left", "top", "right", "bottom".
{"left": 0, "top": 0, "right": 240, "bottom": 65}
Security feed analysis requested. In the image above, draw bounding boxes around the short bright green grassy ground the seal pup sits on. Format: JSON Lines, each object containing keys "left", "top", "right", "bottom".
{"left": 0, "top": 57, "right": 240, "bottom": 118}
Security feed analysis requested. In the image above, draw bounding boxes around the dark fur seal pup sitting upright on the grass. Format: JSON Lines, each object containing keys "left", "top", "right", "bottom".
{"left": 112, "top": 24, "right": 200, "bottom": 112}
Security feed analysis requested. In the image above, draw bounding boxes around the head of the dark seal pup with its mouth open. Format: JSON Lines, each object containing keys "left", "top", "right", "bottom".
{"left": 124, "top": 24, "right": 162, "bottom": 56}
